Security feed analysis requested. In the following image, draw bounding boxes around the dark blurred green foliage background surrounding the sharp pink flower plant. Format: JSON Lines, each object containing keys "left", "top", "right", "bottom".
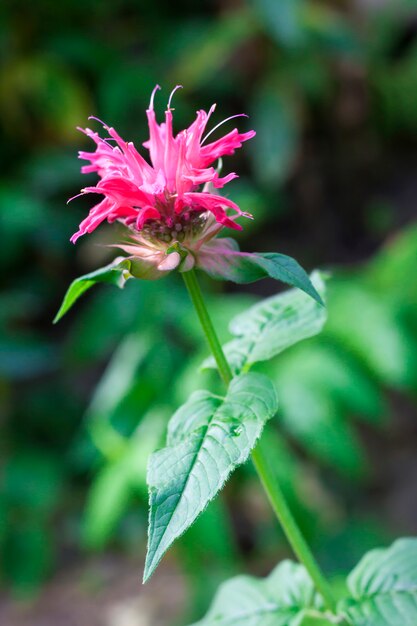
{"left": 0, "top": 0, "right": 417, "bottom": 626}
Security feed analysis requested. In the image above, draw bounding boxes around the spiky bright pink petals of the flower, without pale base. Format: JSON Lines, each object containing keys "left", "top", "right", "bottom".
{"left": 71, "top": 86, "right": 255, "bottom": 242}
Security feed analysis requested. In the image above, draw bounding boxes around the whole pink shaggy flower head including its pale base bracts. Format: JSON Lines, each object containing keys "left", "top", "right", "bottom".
{"left": 71, "top": 85, "right": 255, "bottom": 278}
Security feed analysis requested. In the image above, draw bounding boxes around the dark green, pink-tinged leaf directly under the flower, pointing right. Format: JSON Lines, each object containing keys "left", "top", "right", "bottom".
{"left": 197, "top": 238, "right": 323, "bottom": 304}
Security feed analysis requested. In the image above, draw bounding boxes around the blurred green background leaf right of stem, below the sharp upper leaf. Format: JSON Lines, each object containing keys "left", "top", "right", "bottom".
{"left": 268, "top": 336, "right": 387, "bottom": 472}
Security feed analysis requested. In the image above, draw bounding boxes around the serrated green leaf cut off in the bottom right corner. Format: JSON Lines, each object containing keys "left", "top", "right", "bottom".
{"left": 340, "top": 539, "right": 417, "bottom": 626}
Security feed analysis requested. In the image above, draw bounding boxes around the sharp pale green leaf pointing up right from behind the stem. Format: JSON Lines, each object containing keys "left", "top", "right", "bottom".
{"left": 204, "top": 272, "right": 327, "bottom": 372}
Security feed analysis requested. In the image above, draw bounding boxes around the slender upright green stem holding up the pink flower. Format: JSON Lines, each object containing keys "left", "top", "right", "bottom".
{"left": 182, "top": 270, "right": 336, "bottom": 613}
